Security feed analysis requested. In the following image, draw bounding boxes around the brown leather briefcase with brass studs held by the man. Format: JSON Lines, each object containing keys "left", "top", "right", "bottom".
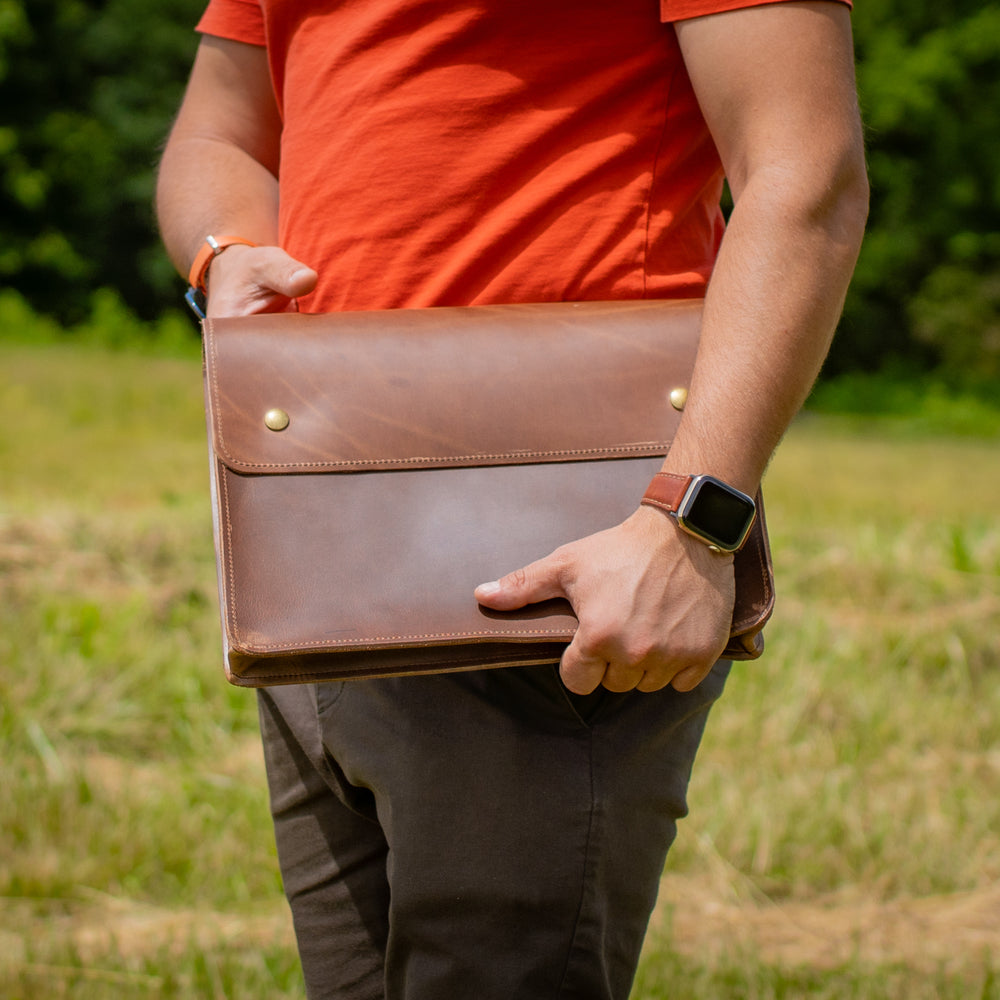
{"left": 204, "top": 301, "right": 774, "bottom": 686}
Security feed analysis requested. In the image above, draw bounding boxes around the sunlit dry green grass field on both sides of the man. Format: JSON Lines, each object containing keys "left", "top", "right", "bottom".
{"left": 0, "top": 344, "right": 1000, "bottom": 1000}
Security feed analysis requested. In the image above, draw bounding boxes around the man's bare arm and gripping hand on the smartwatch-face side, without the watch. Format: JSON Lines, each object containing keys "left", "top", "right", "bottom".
{"left": 476, "top": 0, "right": 868, "bottom": 693}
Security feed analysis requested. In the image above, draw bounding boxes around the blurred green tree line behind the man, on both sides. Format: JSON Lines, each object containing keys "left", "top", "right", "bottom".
{"left": 0, "top": 0, "right": 1000, "bottom": 384}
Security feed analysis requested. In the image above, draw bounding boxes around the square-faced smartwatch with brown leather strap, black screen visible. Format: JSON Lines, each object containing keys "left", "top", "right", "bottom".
{"left": 642, "top": 472, "right": 757, "bottom": 552}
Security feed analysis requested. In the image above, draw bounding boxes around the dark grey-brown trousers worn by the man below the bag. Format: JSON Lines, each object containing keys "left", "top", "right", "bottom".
{"left": 260, "top": 663, "right": 729, "bottom": 1000}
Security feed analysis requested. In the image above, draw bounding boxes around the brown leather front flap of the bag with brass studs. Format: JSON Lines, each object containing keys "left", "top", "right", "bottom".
{"left": 203, "top": 300, "right": 701, "bottom": 474}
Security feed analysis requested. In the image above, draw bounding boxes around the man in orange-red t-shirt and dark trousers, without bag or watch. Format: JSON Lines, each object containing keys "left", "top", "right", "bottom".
{"left": 158, "top": 0, "right": 867, "bottom": 1000}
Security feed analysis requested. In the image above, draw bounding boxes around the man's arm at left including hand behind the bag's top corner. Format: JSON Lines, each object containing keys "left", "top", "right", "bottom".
{"left": 156, "top": 36, "right": 316, "bottom": 316}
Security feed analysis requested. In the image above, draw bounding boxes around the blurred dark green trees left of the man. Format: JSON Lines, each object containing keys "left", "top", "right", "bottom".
{"left": 0, "top": 0, "right": 203, "bottom": 320}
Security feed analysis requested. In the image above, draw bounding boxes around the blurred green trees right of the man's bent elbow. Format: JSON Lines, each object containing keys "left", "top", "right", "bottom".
{"left": 827, "top": 0, "right": 1000, "bottom": 378}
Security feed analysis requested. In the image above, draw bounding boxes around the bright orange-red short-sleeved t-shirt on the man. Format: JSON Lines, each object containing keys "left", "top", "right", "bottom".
{"left": 198, "top": 0, "right": 836, "bottom": 311}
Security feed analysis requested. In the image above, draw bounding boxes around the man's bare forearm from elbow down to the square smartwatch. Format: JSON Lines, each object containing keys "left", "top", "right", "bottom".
{"left": 664, "top": 160, "right": 867, "bottom": 493}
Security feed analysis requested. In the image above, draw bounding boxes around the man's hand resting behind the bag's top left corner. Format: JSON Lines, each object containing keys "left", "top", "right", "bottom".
{"left": 206, "top": 244, "right": 317, "bottom": 317}
